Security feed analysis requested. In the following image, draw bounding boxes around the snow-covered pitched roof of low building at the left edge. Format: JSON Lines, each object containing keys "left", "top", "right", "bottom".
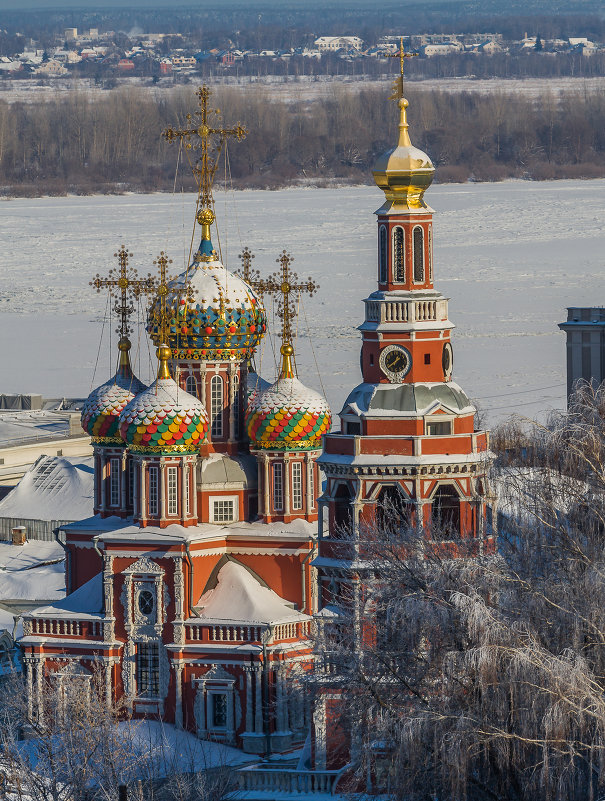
{"left": 0, "top": 456, "right": 94, "bottom": 520}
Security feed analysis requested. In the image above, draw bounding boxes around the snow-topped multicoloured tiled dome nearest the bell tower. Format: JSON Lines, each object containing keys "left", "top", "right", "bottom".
{"left": 246, "top": 344, "right": 332, "bottom": 450}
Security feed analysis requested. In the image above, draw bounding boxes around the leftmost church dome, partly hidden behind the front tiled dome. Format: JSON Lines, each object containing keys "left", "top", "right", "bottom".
{"left": 82, "top": 337, "right": 145, "bottom": 445}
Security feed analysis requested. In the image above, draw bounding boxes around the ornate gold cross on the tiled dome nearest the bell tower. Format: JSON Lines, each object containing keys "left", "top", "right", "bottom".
{"left": 255, "top": 250, "right": 319, "bottom": 378}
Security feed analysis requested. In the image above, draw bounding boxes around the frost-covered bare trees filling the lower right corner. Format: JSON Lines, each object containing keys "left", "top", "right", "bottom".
{"left": 318, "top": 385, "right": 605, "bottom": 801}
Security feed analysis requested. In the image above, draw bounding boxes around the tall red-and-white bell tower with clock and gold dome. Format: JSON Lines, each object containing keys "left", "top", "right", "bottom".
{"left": 318, "top": 39, "right": 495, "bottom": 580}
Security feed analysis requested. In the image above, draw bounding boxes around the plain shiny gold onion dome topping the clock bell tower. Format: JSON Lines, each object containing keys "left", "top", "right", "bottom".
{"left": 373, "top": 97, "right": 435, "bottom": 212}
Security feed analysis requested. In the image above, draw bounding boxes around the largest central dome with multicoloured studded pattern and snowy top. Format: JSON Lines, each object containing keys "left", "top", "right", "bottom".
{"left": 149, "top": 240, "right": 267, "bottom": 361}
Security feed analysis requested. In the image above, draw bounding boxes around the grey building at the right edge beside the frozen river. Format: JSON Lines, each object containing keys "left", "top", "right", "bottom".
{"left": 559, "top": 306, "right": 605, "bottom": 404}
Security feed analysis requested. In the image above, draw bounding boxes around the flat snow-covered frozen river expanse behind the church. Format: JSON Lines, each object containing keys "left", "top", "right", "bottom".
{"left": 0, "top": 180, "right": 605, "bottom": 422}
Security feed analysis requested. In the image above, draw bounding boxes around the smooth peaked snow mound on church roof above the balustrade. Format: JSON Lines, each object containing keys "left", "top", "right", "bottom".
{"left": 196, "top": 560, "right": 308, "bottom": 624}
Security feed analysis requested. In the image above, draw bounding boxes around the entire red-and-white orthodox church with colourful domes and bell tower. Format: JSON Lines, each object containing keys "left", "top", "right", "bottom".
{"left": 21, "top": 50, "right": 495, "bottom": 769}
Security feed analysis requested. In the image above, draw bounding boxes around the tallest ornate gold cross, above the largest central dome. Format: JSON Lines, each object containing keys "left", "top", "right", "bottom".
{"left": 162, "top": 86, "right": 248, "bottom": 225}
